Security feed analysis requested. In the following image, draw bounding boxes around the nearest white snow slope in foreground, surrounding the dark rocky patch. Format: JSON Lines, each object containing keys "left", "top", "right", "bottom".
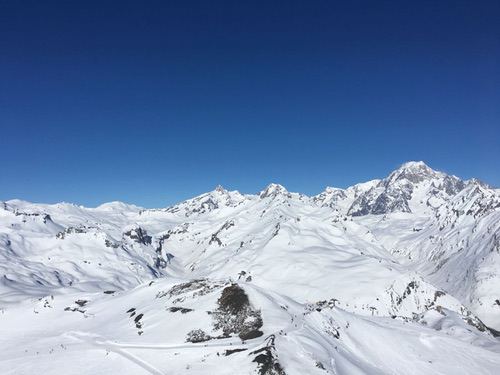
{"left": 0, "top": 279, "right": 500, "bottom": 374}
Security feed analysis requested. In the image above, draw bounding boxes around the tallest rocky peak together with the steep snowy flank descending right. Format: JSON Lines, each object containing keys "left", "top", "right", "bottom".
{"left": 342, "top": 162, "right": 500, "bottom": 329}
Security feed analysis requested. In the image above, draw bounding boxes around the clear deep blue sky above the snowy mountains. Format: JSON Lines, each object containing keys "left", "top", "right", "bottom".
{"left": 0, "top": 0, "right": 500, "bottom": 207}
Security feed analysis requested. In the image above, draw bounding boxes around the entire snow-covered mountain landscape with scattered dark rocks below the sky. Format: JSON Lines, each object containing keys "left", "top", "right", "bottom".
{"left": 0, "top": 162, "right": 500, "bottom": 374}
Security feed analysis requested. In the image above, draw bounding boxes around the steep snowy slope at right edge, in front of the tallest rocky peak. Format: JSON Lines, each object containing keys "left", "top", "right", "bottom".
{"left": 364, "top": 182, "right": 500, "bottom": 329}
